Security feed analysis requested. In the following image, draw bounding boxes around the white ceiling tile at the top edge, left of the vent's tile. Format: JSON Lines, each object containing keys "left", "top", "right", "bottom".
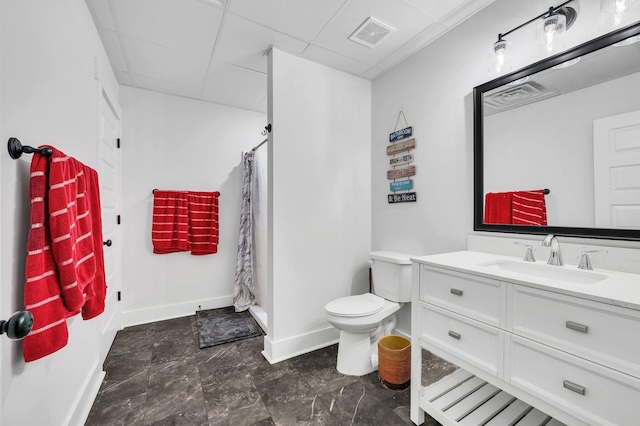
{"left": 229, "top": 0, "right": 346, "bottom": 41}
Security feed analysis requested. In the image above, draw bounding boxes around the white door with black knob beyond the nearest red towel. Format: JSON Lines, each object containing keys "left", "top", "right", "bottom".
{"left": 98, "top": 91, "right": 122, "bottom": 362}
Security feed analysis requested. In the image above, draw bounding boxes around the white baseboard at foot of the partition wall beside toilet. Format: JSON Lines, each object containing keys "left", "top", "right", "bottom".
{"left": 262, "top": 327, "right": 340, "bottom": 364}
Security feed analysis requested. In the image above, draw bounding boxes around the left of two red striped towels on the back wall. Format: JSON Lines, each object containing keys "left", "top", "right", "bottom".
{"left": 151, "top": 189, "right": 189, "bottom": 254}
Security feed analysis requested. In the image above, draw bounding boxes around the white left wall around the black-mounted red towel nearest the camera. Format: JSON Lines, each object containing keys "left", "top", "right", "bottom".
{"left": 0, "top": 0, "right": 118, "bottom": 426}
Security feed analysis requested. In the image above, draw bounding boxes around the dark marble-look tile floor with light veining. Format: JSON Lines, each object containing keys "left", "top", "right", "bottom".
{"left": 85, "top": 316, "right": 453, "bottom": 426}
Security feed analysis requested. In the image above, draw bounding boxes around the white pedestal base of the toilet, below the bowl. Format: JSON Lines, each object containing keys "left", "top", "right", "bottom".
{"left": 337, "top": 331, "right": 378, "bottom": 376}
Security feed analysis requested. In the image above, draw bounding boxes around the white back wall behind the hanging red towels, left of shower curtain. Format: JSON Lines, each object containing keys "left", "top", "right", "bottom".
{"left": 120, "top": 86, "right": 267, "bottom": 326}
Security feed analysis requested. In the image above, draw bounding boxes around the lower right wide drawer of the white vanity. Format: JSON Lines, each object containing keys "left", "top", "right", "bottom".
{"left": 506, "top": 336, "right": 640, "bottom": 426}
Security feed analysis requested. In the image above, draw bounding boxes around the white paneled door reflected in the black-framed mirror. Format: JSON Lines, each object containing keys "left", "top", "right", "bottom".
{"left": 593, "top": 111, "right": 640, "bottom": 229}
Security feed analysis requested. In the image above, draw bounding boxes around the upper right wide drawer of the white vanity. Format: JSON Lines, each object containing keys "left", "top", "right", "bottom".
{"left": 507, "top": 285, "right": 640, "bottom": 378}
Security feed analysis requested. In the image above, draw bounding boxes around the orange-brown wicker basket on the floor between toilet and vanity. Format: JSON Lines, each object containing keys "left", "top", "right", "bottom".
{"left": 378, "top": 334, "right": 411, "bottom": 390}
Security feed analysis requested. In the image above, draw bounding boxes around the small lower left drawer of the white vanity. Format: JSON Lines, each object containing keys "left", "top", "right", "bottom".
{"left": 420, "top": 303, "right": 504, "bottom": 378}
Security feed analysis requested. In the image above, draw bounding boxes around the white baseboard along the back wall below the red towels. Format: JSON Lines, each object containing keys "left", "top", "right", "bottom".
{"left": 122, "top": 296, "right": 233, "bottom": 327}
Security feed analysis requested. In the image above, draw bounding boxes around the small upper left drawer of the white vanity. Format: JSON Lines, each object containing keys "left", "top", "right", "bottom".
{"left": 420, "top": 265, "right": 505, "bottom": 327}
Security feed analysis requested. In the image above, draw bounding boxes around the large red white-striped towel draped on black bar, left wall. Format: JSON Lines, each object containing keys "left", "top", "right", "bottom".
{"left": 23, "top": 147, "right": 106, "bottom": 361}
